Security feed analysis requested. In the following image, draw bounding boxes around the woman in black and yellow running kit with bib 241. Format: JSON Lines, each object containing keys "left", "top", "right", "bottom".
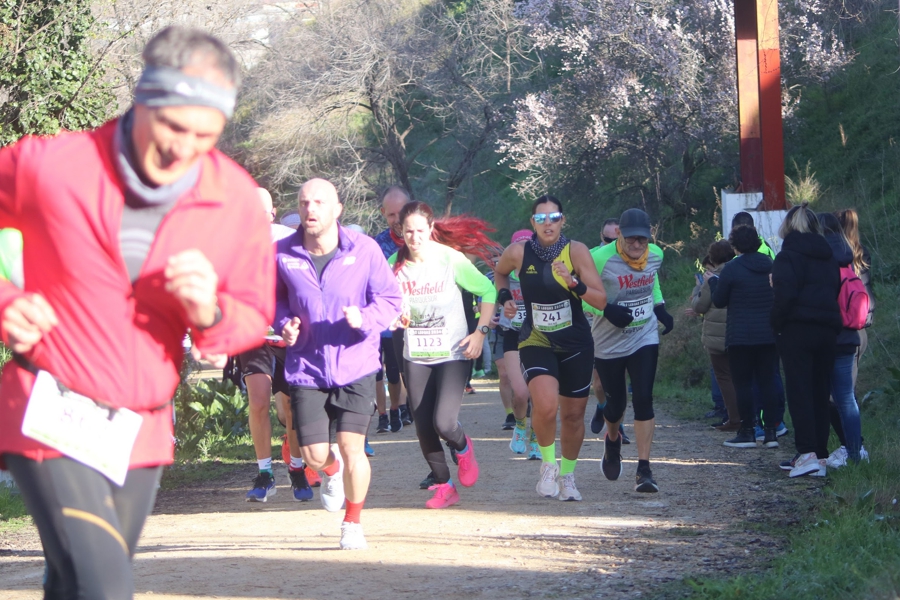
{"left": 495, "top": 196, "right": 606, "bottom": 501}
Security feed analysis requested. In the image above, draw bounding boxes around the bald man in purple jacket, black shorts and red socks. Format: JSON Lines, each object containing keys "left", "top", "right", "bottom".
{"left": 274, "top": 179, "right": 401, "bottom": 550}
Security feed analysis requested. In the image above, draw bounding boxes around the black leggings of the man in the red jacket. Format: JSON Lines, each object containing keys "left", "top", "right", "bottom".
{"left": 3, "top": 454, "right": 162, "bottom": 600}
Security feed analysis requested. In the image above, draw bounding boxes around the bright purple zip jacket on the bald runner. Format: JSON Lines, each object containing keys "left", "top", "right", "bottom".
{"left": 273, "top": 227, "right": 401, "bottom": 389}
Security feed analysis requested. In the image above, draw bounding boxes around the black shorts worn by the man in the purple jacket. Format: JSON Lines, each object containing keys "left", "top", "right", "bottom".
{"left": 291, "top": 373, "right": 375, "bottom": 446}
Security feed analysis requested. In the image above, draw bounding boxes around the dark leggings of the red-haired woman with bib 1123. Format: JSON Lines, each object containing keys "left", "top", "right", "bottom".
{"left": 403, "top": 360, "right": 472, "bottom": 483}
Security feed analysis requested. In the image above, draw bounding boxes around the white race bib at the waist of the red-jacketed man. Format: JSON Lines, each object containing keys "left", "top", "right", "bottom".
{"left": 22, "top": 371, "right": 143, "bottom": 486}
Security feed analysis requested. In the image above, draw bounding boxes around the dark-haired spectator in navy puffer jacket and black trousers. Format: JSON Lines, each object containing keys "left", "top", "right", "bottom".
{"left": 709, "top": 226, "right": 778, "bottom": 448}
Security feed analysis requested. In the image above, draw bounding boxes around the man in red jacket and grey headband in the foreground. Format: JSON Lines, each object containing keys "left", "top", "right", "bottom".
{"left": 0, "top": 27, "right": 275, "bottom": 598}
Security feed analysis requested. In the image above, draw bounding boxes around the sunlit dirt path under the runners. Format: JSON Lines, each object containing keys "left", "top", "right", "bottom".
{"left": 0, "top": 381, "right": 819, "bottom": 600}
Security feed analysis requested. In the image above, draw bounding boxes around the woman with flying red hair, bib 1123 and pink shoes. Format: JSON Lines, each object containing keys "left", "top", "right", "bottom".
{"left": 389, "top": 202, "right": 500, "bottom": 508}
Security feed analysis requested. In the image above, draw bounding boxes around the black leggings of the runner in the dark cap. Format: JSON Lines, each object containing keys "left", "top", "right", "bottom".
{"left": 594, "top": 344, "right": 659, "bottom": 423}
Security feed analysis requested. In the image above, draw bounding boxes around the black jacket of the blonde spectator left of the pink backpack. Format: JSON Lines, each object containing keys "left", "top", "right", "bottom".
{"left": 772, "top": 231, "right": 843, "bottom": 335}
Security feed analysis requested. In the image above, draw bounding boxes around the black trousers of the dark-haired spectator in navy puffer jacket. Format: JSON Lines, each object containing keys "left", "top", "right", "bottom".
{"left": 728, "top": 344, "right": 779, "bottom": 429}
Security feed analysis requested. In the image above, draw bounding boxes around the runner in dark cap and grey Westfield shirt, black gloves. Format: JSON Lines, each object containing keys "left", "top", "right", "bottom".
{"left": 591, "top": 208, "right": 674, "bottom": 492}
